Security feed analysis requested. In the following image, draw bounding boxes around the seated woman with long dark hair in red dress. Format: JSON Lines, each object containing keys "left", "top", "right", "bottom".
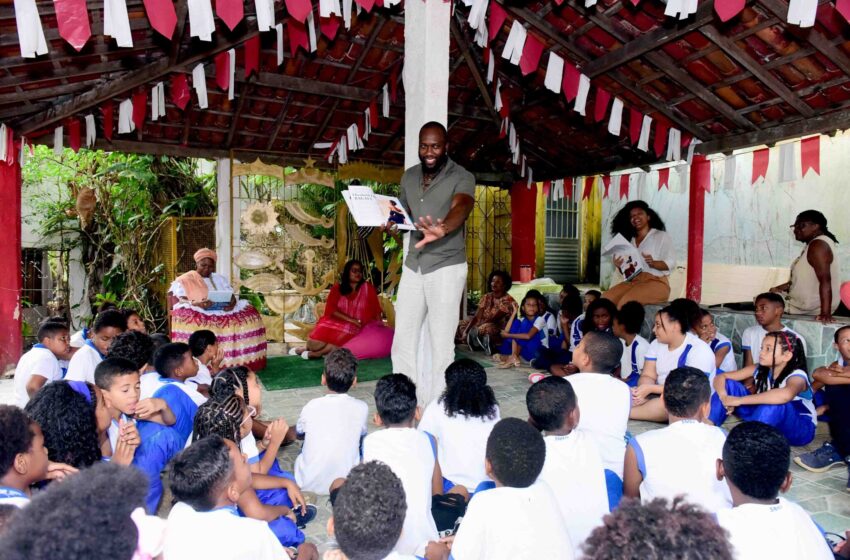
{"left": 289, "top": 260, "right": 381, "bottom": 360}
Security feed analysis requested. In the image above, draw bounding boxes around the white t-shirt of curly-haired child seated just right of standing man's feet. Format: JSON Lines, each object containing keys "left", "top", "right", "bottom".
{"left": 419, "top": 399, "right": 501, "bottom": 491}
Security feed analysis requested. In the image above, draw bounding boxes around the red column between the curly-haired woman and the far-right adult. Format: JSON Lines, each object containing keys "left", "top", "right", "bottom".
{"left": 685, "top": 155, "right": 711, "bottom": 302}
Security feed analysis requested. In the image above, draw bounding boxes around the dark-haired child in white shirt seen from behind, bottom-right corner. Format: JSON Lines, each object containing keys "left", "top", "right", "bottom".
{"left": 717, "top": 422, "right": 833, "bottom": 560}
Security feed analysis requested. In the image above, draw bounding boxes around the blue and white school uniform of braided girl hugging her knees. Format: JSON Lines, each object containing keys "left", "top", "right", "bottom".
{"left": 709, "top": 368, "right": 818, "bottom": 445}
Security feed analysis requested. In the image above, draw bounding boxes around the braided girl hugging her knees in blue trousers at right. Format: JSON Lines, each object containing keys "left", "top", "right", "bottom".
{"left": 709, "top": 331, "right": 817, "bottom": 445}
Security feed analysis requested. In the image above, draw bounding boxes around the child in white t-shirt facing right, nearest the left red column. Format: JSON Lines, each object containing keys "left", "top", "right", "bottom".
{"left": 15, "top": 321, "right": 71, "bottom": 408}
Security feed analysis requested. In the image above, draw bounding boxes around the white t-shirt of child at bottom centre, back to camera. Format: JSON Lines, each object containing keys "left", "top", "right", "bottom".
{"left": 451, "top": 483, "right": 573, "bottom": 560}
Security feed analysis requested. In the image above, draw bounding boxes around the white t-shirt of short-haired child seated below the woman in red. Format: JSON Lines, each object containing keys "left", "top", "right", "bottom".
{"left": 295, "top": 393, "right": 369, "bottom": 494}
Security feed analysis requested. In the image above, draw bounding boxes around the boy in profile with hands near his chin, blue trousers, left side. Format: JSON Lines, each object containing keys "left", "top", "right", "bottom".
{"left": 94, "top": 357, "right": 186, "bottom": 515}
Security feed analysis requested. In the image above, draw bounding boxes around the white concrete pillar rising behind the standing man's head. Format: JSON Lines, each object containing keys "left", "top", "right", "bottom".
{"left": 403, "top": 0, "right": 451, "bottom": 169}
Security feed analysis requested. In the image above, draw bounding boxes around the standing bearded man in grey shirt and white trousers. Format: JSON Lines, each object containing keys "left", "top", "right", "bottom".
{"left": 387, "top": 122, "right": 475, "bottom": 404}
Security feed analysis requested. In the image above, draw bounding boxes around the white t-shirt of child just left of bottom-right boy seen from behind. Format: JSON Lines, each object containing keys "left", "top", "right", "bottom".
{"left": 629, "top": 420, "right": 732, "bottom": 512}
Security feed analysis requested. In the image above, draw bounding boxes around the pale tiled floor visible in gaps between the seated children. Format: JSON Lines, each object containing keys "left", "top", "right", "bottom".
{"left": 0, "top": 350, "right": 850, "bottom": 544}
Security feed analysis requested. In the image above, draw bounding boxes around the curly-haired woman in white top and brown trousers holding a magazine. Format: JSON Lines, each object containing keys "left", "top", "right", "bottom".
{"left": 602, "top": 200, "right": 676, "bottom": 307}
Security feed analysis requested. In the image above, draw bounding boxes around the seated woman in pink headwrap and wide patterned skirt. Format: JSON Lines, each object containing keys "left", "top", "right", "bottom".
{"left": 168, "top": 248, "right": 266, "bottom": 371}
